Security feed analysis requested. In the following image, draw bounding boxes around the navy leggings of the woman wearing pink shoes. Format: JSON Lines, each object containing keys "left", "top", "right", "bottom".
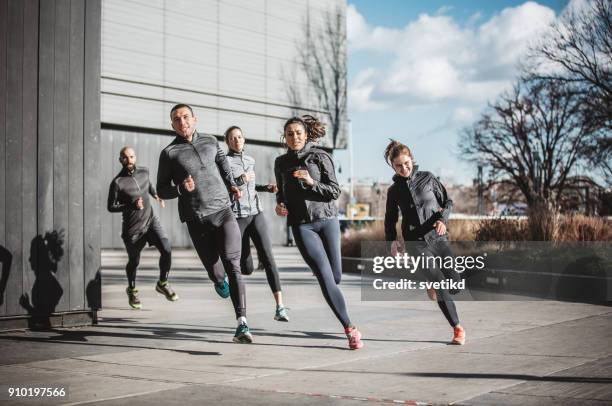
{"left": 291, "top": 217, "right": 351, "bottom": 328}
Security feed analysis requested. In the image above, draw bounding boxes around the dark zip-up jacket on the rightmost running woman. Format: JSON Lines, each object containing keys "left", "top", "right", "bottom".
{"left": 385, "top": 166, "right": 453, "bottom": 242}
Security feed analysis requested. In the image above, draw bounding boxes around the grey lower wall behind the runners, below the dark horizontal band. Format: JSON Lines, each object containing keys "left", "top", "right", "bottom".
{"left": 100, "top": 127, "right": 285, "bottom": 249}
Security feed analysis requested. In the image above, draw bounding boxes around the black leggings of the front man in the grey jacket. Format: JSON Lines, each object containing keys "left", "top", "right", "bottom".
{"left": 187, "top": 207, "right": 246, "bottom": 318}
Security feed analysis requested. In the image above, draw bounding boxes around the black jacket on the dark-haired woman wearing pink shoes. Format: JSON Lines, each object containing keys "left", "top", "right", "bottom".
{"left": 274, "top": 142, "right": 340, "bottom": 225}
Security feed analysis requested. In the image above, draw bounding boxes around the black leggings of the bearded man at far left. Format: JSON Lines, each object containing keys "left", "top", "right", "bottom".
{"left": 123, "top": 216, "right": 172, "bottom": 288}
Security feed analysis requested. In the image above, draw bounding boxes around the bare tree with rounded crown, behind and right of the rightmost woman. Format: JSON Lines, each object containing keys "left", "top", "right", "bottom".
{"left": 459, "top": 81, "right": 592, "bottom": 208}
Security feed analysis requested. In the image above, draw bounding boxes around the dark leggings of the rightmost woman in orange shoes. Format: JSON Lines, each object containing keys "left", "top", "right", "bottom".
{"left": 417, "top": 240, "right": 461, "bottom": 327}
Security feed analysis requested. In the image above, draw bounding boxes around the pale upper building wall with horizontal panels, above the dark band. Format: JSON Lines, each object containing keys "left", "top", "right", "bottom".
{"left": 102, "top": 0, "right": 346, "bottom": 145}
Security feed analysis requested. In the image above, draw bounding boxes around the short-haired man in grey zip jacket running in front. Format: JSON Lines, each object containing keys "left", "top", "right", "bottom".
{"left": 157, "top": 104, "right": 253, "bottom": 343}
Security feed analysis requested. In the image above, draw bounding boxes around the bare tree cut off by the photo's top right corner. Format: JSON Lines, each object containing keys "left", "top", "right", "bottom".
{"left": 526, "top": 0, "right": 612, "bottom": 182}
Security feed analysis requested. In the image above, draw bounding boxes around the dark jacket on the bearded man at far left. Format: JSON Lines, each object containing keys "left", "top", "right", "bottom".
{"left": 107, "top": 166, "right": 157, "bottom": 242}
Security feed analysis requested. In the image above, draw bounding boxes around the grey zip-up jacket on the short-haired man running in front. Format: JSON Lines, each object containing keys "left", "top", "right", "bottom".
{"left": 157, "top": 132, "right": 236, "bottom": 223}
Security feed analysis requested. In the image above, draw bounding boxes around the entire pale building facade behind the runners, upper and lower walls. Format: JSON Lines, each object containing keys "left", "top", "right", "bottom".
{"left": 100, "top": 0, "right": 346, "bottom": 248}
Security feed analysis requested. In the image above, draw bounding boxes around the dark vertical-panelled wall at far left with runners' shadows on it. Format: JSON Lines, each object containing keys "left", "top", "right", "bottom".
{"left": 0, "top": 0, "right": 101, "bottom": 316}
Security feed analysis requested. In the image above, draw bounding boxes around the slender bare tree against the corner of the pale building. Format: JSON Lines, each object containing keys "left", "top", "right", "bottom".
{"left": 283, "top": 6, "right": 347, "bottom": 147}
